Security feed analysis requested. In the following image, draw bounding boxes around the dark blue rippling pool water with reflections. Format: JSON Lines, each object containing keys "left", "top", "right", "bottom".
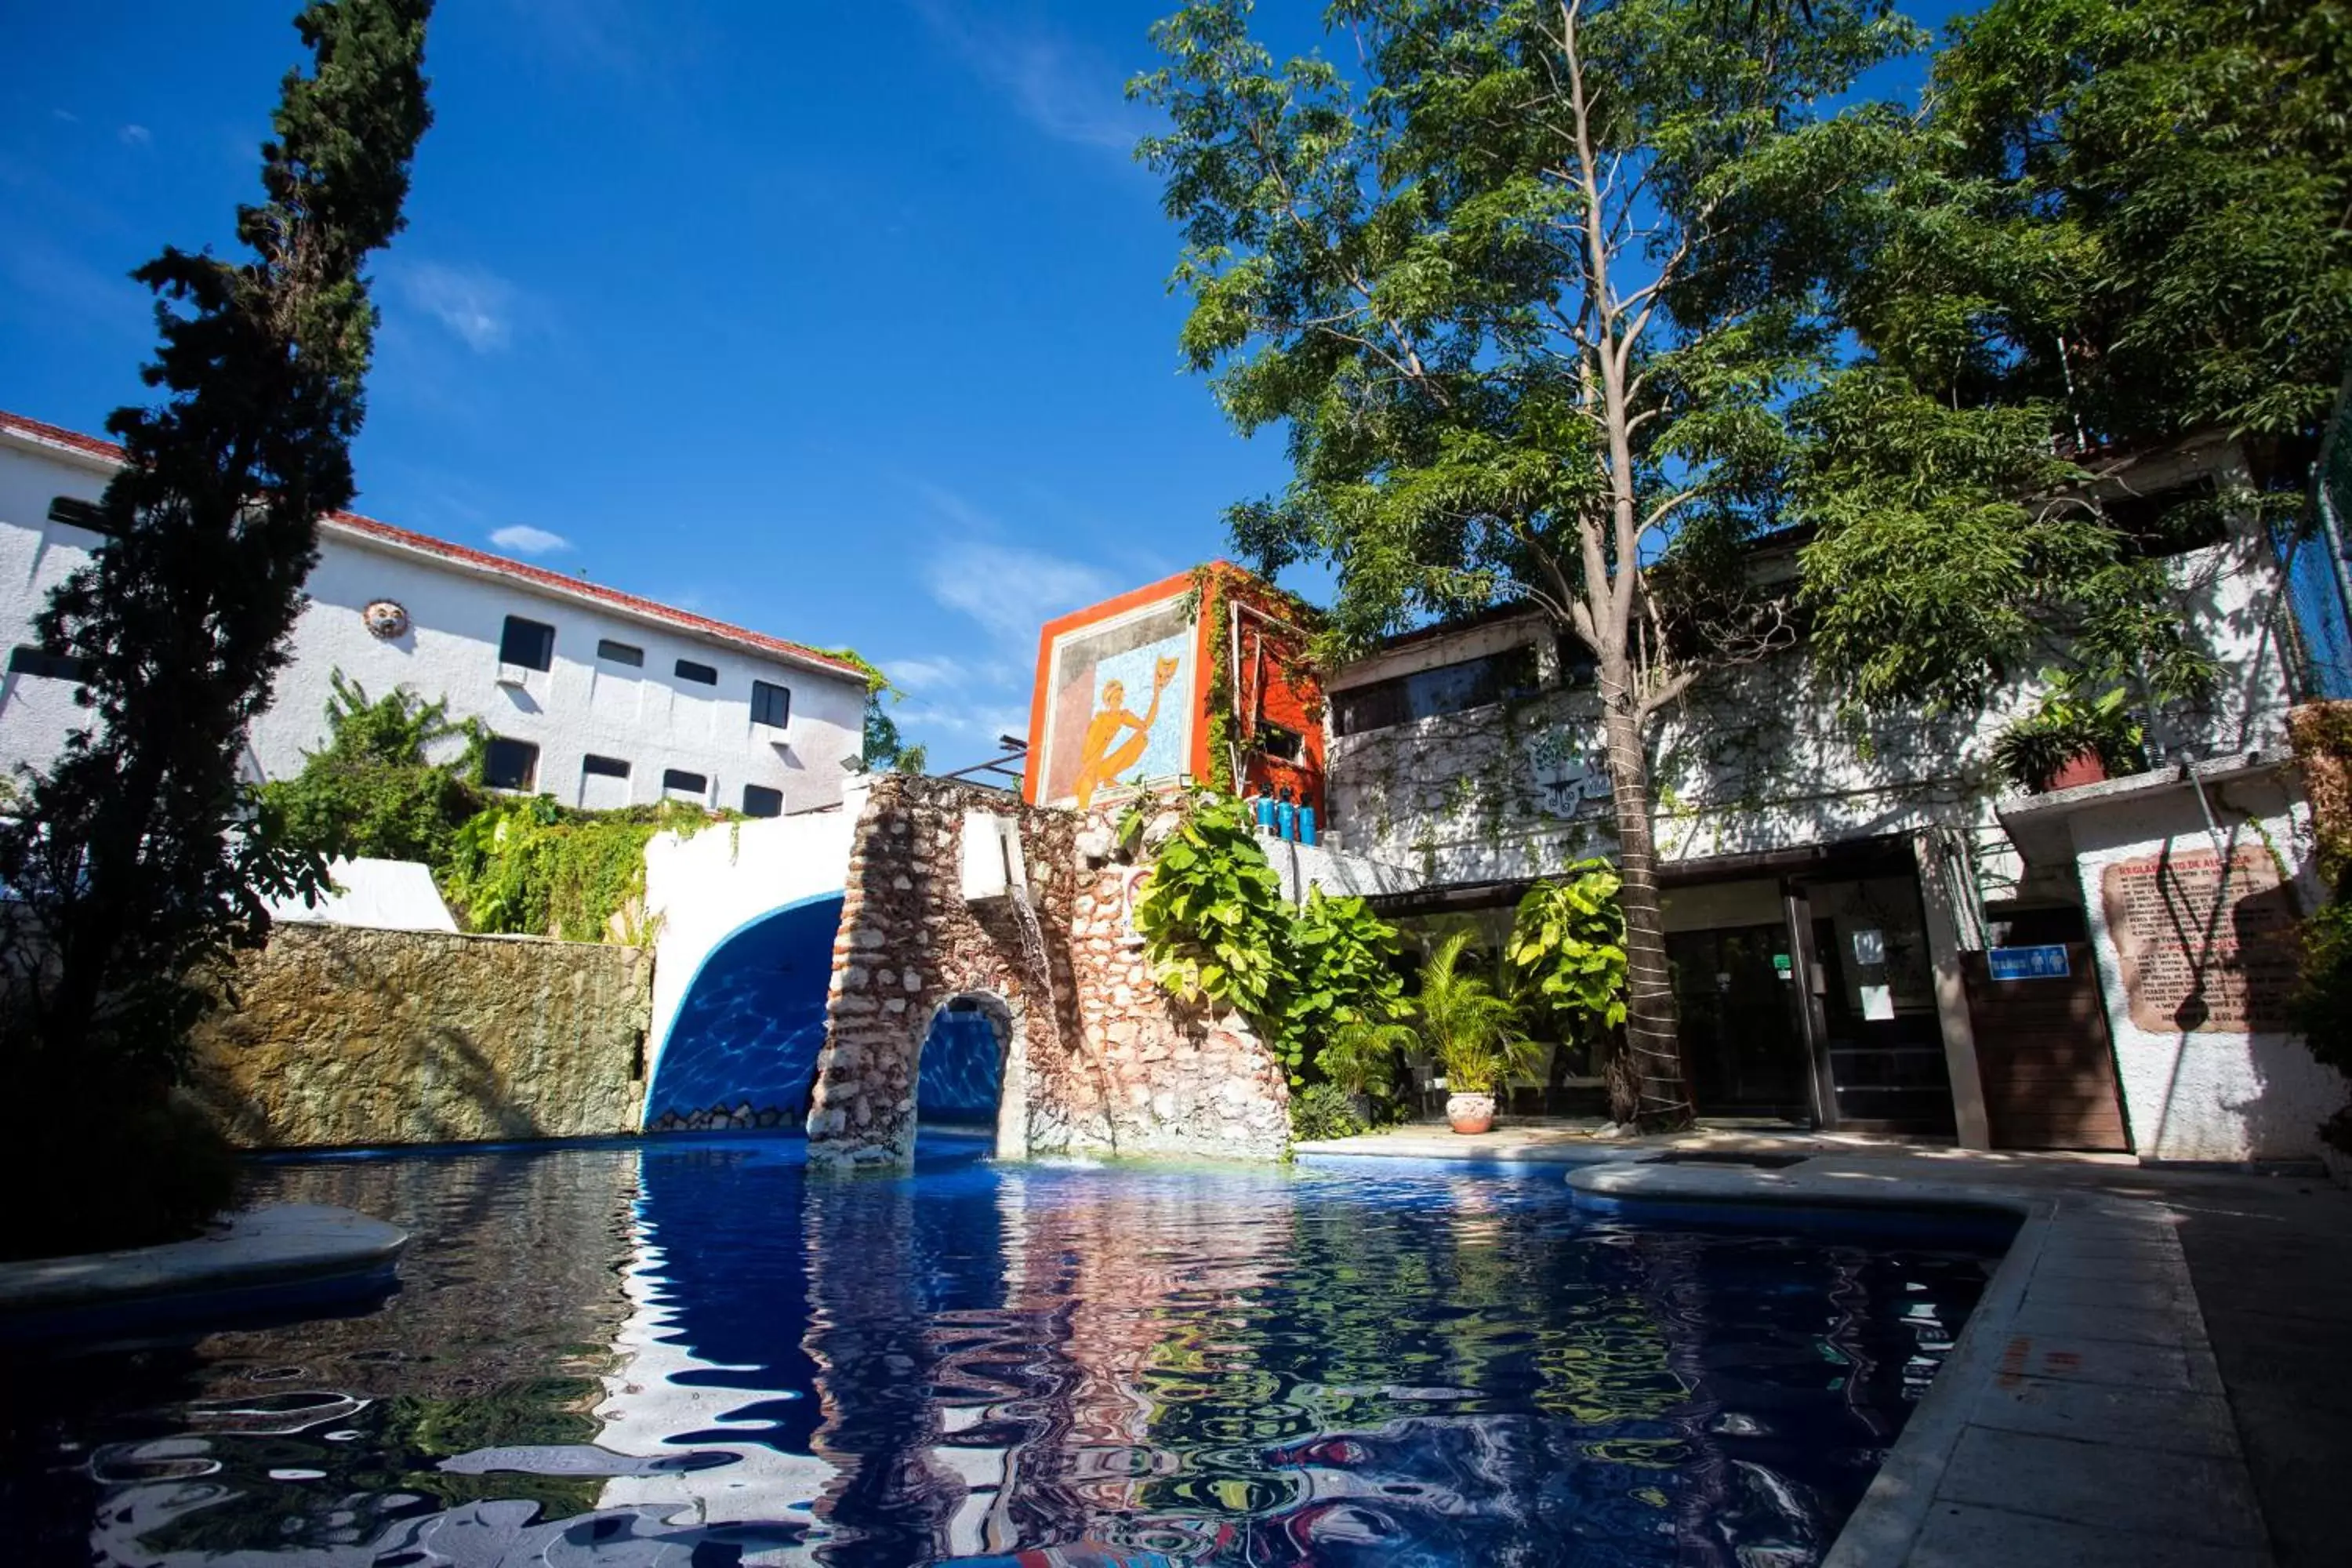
{"left": 0, "top": 1138, "right": 2002, "bottom": 1568}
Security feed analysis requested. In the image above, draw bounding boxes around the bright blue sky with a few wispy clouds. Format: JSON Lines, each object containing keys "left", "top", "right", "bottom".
{"left": 0, "top": 0, "right": 1950, "bottom": 767}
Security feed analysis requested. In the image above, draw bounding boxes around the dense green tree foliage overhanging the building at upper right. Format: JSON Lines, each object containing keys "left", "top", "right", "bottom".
{"left": 1795, "top": 0, "right": 2352, "bottom": 710}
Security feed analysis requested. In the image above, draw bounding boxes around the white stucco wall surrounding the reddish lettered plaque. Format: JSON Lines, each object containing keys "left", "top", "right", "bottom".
{"left": 2070, "top": 774, "right": 2347, "bottom": 1161}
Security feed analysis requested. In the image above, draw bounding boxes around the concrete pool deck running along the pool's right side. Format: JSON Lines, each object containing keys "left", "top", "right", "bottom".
{"left": 1301, "top": 1123, "right": 2352, "bottom": 1568}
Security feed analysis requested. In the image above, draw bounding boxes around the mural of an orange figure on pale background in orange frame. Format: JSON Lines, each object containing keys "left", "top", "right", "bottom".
{"left": 1042, "top": 600, "right": 1192, "bottom": 808}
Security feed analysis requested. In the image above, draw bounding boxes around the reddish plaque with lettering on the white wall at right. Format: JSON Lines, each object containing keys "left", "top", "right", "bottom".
{"left": 2100, "top": 846, "right": 2296, "bottom": 1034}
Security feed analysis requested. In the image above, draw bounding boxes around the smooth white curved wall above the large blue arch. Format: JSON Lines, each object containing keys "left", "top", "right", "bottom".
{"left": 644, "top": 785, "right": 866, "bottom": 1088}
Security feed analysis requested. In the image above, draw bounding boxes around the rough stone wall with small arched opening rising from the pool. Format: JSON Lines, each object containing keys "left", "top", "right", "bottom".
{"left": 809, "top": 776, "right": 1289, "bottom": 1163}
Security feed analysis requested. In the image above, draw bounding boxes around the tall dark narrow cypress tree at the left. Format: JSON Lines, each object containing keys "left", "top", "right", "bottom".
{"left": 0, "top": 0, "right": 433, "bottom": 1102}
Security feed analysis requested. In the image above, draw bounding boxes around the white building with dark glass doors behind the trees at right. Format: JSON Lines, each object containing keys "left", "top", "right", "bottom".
{"left": 1322, "top": 442, "right": 2345, "bottom": 1161}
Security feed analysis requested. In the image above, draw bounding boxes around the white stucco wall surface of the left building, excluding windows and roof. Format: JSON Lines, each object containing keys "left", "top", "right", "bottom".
{"left": 0, "top": 433, "right": 866, "bottom": 811}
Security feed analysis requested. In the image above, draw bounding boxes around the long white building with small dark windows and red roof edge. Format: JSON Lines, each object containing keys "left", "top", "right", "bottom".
{"left": 0, "top": 414, "right": 866, "bottom": 815}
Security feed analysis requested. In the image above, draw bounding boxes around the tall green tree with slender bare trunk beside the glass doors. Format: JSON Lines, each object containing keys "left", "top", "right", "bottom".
{"left": 1131, "top": 0, "right": 1915, "bottom": 1123}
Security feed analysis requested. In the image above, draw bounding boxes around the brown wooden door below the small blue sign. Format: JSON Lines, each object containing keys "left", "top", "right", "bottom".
{"left": 1959, "top": 942, "right": 2131, "bottom": 1152}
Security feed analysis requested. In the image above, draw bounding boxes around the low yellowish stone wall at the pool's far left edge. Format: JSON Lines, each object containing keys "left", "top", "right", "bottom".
{"left": 193, "top": 924, "right": 654, "bottom": 1147}
